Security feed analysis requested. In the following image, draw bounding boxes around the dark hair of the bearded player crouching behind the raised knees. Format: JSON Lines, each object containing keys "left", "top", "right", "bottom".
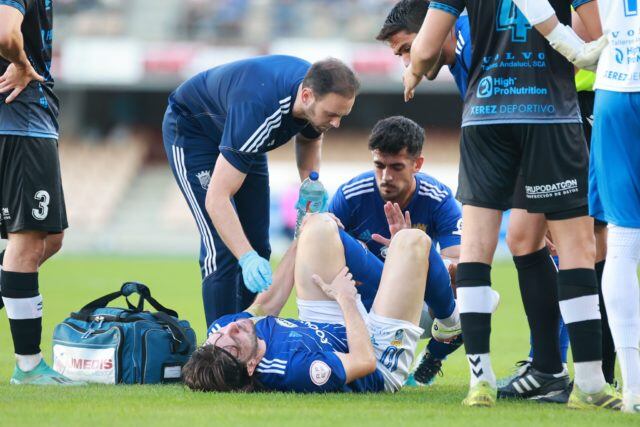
{"left": 369, "top": 116, "right": 424, "bottom": 157}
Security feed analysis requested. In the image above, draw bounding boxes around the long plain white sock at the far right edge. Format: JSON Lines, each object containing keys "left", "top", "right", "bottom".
{"left": 602, "top": 226, "right": 640, "bottom": 393}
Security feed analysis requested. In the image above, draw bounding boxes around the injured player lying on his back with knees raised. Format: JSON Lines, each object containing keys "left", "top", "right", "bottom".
{"left": 183, "top": 214, "right": 438, "bottom": 392}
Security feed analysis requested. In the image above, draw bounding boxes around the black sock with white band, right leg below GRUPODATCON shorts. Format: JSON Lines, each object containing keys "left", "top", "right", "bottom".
{"left": 558, "top": 268, "right": 602, "bottom": 363}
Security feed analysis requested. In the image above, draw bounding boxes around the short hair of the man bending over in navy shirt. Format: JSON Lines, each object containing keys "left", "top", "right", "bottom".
{"left": 302, "top": 58, "right": 360, "bottom": 99}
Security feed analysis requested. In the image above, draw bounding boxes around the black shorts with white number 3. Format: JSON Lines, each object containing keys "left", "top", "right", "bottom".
{"left": 0, "top": 135, "right": 68, "bottom": 239}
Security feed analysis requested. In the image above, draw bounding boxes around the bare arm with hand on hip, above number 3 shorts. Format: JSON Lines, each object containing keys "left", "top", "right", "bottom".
{"left": 0, "top": 1, "right": 44, "bottom": 104}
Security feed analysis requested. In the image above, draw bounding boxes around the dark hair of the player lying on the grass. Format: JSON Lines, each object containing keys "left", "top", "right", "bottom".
{"left": 182, "top": 344, "right": 259, "bottom": 392}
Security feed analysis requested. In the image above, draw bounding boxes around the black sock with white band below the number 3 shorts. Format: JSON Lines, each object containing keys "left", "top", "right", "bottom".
{"left": 0, "top": 271, "right": 42, "bottom": 355}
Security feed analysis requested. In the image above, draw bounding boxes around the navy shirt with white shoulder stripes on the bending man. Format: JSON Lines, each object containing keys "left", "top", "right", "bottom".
{"left": 169, "top": 55, "right": 320, "bottom": 173}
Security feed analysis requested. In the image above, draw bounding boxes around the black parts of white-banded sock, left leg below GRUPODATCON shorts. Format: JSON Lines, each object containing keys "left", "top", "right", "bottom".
{"left": 456, "top": 262, "right": 491, "bottom": 354}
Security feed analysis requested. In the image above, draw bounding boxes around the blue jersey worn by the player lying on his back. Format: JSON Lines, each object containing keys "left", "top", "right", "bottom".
{"left": 208, "top": 312, "right": 384, "bottom": 393}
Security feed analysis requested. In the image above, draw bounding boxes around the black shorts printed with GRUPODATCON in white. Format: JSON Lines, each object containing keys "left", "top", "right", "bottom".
{"left": 457, "top": 123, "right": 589, "bottom": 219}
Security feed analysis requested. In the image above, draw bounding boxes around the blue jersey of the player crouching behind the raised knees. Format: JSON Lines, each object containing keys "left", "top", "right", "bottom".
{"left": 329, "top": 171, "right": 462, "bottom": 260}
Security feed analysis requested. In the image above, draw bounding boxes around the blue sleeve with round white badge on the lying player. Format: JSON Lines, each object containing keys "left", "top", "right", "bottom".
{"left": 283, "top": 351, "right": 347, "bottom": 393}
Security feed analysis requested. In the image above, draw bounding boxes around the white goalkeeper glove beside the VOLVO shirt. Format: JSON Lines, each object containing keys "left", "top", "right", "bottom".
{"left": 547, "top": 24, "right": 609, "bottom": 71}
